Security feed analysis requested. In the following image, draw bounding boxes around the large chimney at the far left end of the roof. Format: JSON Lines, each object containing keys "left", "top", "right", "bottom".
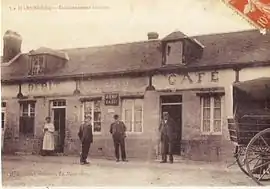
{"left": 3, "top": 30, "right": 22, "bottom": 62}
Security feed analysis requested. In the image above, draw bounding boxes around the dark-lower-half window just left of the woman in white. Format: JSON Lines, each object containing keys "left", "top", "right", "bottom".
{"left": 20, "top": 102, "right": 35, "bottom": 134}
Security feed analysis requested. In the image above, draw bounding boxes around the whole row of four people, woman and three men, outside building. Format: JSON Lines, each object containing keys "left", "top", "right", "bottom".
{"left": 42, "top": 112, "right": 175, "bottom": 165}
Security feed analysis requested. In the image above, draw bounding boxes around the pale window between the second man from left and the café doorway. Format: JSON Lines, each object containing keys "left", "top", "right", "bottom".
{"left": 122, "top": 99, "right": 143, "bottom": 132}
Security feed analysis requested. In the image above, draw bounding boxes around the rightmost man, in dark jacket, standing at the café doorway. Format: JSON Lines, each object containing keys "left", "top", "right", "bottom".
{"left": 159, "top": 112, "right": 175, "bottom": 163}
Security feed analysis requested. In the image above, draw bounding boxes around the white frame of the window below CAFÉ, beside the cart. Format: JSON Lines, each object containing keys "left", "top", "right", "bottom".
{"left": 200, "top": 94, "right": 224, "bottom": 135}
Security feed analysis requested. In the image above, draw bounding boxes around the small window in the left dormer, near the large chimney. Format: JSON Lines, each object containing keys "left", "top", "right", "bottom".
{"left": 30, "top": 55, "right": 45, "bottom": 75}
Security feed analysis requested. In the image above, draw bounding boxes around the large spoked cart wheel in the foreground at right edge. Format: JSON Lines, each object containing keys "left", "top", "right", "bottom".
{"left": 245, "top": 128, "right": 270, "bottom": 185}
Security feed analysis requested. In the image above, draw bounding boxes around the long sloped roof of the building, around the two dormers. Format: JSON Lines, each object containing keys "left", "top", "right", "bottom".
{"left": 1, "top": 30, "right": 270, "bottom": 80}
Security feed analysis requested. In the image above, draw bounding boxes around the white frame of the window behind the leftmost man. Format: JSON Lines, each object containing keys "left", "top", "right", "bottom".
{"left": 82, "top": 99, "right": 102, "bottom": 135}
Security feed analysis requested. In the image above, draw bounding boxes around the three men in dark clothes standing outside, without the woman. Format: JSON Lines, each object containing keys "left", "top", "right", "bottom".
{"left": 78, "top": 112, "right": 175, "bottom": 165}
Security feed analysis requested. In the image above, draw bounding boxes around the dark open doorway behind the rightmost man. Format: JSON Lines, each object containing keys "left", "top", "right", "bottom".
{"left": 160, "top": 95, "right": 182, "bottom": 155}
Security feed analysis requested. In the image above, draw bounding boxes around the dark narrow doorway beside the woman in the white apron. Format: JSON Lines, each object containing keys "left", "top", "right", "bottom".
{"left": 52, "top": 100, "right": 66, "bottom": 153}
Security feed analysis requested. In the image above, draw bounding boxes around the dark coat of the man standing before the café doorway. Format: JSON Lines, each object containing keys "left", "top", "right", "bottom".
{"left": 159, "top": 118, "right": 176, "bottom": 142}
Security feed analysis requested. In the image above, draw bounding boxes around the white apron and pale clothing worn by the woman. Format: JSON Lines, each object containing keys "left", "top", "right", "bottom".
{"left": 42, "top": 123, "right": 54, "bottom": 150}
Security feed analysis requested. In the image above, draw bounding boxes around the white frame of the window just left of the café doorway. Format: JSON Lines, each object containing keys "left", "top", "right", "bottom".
{"left": 121, "top": 98, "right": 144, "bottom": 134}
